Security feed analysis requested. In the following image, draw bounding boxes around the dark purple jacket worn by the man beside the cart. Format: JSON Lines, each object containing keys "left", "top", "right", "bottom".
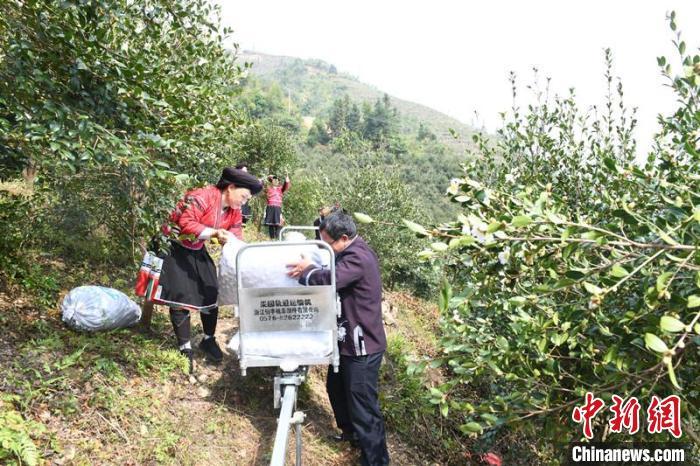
{"left": 299, "top": 236, "right": 386, "bottom": 356}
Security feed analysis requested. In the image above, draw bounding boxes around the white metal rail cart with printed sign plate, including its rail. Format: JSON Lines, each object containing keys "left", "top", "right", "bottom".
{"left": 236, "top": 241, "right": 340, "bottom": 466}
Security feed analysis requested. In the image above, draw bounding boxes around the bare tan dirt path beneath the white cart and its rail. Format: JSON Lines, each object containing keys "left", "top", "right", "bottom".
{"left": 157, "top": 318, "right": 425, "bottom": 466}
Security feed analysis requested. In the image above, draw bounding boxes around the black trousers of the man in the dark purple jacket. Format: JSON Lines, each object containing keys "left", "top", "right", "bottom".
{"left": 326, "top": 352, "right": 389, "bottom": 466}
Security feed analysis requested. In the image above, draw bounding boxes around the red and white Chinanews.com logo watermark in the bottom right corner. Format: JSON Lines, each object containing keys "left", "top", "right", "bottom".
{"left": 565, "top": 392, "right": 700, "bottom": 466}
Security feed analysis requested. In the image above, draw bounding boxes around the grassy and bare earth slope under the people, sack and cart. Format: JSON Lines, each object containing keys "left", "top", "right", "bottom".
{"left": 0, "top": 249, "right": 476, "bottom": 465}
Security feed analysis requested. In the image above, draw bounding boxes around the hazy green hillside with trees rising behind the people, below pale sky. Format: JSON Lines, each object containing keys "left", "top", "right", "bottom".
{"left": 237, "top": 52, "right": 482, "bottom": 221}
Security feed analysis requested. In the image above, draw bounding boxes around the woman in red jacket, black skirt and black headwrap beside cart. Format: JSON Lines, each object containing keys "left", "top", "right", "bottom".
{"left": 154, "top": 168, "right": 262, "bottom": 362}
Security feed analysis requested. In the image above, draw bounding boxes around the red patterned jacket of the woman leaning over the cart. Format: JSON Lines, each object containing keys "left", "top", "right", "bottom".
{"left": 163, "top": 186, "right": 243, "bottom": 249}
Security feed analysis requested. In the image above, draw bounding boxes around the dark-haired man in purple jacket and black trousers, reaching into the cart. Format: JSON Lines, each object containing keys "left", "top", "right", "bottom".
{"left": 289, "top": 211, "right": 389, "bottom": 466}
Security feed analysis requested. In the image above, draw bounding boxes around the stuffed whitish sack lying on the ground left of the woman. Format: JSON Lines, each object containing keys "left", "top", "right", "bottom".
{"left": 61, "top": 286, "right": 141, "bottom": 332}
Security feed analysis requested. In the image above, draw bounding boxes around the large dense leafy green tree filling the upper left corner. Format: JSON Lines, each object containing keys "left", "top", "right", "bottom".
{"left": 0, "top": 0, "right": 252, "bottom": 257}
